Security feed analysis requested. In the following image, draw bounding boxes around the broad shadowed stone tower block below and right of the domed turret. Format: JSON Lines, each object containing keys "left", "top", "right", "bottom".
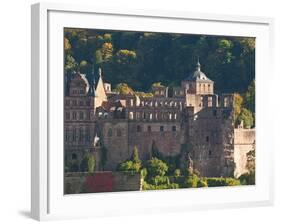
{"left": 188, "top": 106, "right": 234, "bottom": 177}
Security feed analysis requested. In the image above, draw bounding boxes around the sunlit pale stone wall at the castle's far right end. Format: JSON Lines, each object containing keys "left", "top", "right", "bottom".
{"left": 234, "top": 129, "right": 255, "bottom": 177}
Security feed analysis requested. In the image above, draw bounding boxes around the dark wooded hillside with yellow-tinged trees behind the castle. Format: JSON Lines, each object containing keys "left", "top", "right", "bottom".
{"left": 64, "top": 28, "right": 255, "bottom": 93}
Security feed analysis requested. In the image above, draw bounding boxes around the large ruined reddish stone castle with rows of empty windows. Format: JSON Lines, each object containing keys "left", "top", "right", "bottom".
{"left": 64, "top": 61, "right": 255, "bottom": 177}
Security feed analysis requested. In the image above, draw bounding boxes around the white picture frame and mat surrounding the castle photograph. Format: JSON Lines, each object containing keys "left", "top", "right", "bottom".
{"left": 31, "top": 3, "right": 274, "bottom": 220}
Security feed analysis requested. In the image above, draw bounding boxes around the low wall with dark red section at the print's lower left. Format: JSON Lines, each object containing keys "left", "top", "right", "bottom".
{"left": 64, "top": 171, "right": 142, "bottom": 194}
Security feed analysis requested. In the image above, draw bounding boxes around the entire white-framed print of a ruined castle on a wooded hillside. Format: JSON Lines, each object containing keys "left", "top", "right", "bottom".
{"left": 31, "top": 3, "right": 273, "bottom": 220}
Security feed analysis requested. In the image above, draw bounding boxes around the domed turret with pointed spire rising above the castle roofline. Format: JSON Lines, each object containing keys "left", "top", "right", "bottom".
{"left": 181, "top": 58, "right": 214, "bottom": 95}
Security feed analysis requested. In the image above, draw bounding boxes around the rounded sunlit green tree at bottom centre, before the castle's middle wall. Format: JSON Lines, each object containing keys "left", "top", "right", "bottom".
{"left": 146, "top": 158, "right": 168, "bottom": 177}
